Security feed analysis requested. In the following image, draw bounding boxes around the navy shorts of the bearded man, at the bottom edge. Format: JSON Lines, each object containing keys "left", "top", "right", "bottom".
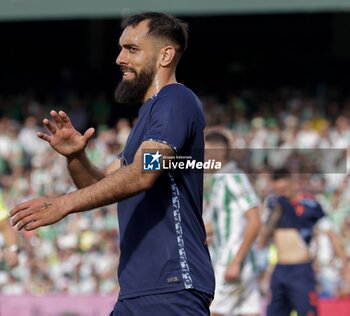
{"left": 109, "top": 290, "right": 211, "bottom": 316}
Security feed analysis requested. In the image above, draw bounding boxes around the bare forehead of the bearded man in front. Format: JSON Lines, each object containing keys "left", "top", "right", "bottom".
{"left": 119, "top": 20, "right": 151, "bottom": 46}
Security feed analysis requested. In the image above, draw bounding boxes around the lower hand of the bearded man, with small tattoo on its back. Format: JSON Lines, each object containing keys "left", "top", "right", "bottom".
{"left": 10, "top": 197, "right": 67, "bottom": 230}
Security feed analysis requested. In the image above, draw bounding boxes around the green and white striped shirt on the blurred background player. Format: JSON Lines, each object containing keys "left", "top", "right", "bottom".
{"left": 206, "top": 162, "right": 259, "bottom": 265}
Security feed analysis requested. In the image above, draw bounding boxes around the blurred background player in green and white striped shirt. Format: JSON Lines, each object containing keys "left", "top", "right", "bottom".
{"left": 205, "top": 131, "right": 261, "bottom": 316}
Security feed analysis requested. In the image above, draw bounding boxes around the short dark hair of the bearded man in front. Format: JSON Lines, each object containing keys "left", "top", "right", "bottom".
{"left": 121, "top": 12, "right": 188, "bottom": 55}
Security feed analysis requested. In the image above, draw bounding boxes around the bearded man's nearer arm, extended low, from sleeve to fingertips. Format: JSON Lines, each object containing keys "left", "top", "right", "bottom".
{"left": 10, "top": 141, "right": 175, "bottom": 230}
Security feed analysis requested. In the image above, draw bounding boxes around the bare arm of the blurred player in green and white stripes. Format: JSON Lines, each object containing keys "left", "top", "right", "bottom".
{"left": 225, "top": 207, "right": 261, "bottom": 281}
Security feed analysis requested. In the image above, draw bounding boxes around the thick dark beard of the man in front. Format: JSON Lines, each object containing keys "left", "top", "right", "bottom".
{"left": 114, "top": 61, "right": 156, "bottom": 105}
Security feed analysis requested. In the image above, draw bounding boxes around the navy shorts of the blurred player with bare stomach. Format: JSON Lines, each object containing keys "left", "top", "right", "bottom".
{"left": 267, "top": 263, "right": 317, "bottom": 316}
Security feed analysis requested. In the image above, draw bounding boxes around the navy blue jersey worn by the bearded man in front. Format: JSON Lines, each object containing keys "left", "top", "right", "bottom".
{"left": 118, "top": 84, "right": 215, "bottom": 299}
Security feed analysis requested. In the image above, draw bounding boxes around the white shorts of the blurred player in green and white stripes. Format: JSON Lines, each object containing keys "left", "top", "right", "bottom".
{"left": 210, "top": 262, "right": 261, "bottom": 316}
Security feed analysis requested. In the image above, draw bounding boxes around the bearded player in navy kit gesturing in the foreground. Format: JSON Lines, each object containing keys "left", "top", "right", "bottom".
{"left": 11, "top": 13, "right": 215, "bottom": 316}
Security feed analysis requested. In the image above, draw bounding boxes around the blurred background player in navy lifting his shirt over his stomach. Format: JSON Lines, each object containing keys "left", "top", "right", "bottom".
{"left": 258, "top": 168, "right": 348, "bottom": 316}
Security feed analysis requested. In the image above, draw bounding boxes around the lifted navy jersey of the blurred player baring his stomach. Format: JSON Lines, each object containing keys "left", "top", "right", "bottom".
{"left": 268, "top": 193, "right": 325, "bottom": 244}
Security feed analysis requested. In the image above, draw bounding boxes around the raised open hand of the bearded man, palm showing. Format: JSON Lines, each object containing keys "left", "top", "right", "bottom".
{"left": 37, "top": 110, "right": 95, "bottom": 157}
